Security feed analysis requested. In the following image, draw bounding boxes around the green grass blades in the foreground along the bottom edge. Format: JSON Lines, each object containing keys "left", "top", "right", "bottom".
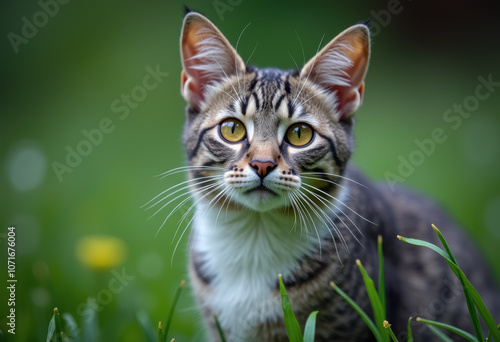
{"left": 46, "top": 225, "right": 500, "bottom": 342}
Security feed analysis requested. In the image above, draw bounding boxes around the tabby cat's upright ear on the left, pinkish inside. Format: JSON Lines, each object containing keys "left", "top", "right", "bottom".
{"left": 181, "top": 12, "right": 245, "bottom": 110}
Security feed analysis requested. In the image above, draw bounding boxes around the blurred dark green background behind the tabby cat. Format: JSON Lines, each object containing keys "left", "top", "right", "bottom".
{"left": 0, "top": 0, "right": 500, "bottom": 341}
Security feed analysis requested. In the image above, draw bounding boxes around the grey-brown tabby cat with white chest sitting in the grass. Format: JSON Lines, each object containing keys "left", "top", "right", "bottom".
{"left": 167, "top": 11, "right": 500, "bottom": 341}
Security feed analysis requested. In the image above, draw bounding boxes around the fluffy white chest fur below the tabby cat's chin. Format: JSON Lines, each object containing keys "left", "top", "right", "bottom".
{"left": 192, "top": 209, "right": 324, "bottom": 340}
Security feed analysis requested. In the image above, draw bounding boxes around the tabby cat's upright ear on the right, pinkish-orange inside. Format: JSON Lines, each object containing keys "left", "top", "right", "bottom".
{"left": 300, "top": 24, "right": 370, "bottom": 120}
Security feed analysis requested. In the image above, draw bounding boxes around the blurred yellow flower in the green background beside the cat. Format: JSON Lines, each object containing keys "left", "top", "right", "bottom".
{"left": 76, "top": 236, "right": 126, "bottom": 270}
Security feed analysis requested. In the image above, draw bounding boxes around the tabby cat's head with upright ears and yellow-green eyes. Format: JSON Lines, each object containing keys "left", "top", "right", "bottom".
{"left": 181, "top": 12, "right": 370, "bottom": 211}
